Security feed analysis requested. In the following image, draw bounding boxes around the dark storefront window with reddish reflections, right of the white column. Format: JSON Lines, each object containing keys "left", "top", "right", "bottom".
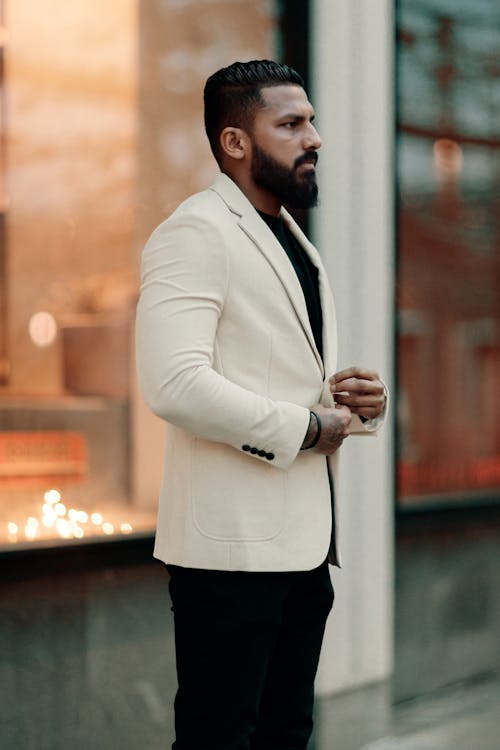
{"left": 397, "top": 0, "right": 500, "bottom": 508}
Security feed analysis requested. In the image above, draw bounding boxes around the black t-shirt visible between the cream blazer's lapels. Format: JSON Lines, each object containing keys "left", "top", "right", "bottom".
{"left": 258, "top": 211, "right": 323, "bottom": 358}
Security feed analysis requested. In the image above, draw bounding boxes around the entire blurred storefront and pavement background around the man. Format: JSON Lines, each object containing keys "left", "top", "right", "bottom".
{"left": 0, "top": 0, "right": 500, "bottom": 750}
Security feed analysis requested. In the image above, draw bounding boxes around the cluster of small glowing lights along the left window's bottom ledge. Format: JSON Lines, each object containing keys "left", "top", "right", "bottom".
{"left": 2, "top": 489, "right": 133, "bottom": 542}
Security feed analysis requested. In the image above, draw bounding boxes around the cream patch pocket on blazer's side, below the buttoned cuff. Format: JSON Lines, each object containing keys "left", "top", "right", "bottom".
{"left": 191, "top": 439, "right": 287, "bottom": 542}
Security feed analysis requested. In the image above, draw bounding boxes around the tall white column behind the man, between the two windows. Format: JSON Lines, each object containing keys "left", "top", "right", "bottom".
{"left": 311, "top": 0, "right": 395, "bottom": 694}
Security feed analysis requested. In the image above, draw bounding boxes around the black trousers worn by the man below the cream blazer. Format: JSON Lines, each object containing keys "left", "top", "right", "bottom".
{"left": 167, "top": 562, "right": 333, "bottom": 750}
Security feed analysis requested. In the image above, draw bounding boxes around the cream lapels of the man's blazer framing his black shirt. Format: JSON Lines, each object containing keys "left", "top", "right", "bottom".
{"left": 210, "top": 173, "right": 328, "bottom": 374}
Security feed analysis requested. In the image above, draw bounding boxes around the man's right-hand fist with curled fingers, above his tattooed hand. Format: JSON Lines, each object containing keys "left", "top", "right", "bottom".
{"left": 329, "top": 367, "right": 386, "bottom": 419}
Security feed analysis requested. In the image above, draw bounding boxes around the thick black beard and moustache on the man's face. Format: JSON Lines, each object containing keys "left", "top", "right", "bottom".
{"left": 251, "top": 142, "right": 318, "bottom": 208}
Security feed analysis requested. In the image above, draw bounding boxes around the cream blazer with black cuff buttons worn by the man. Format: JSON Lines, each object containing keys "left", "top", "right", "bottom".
{"left": 137, "top": 174, "right": 380, "bottom": 571}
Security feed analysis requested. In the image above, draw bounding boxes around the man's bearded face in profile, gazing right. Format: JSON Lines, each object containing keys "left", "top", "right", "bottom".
{"left": 251, "top": 84, "right": 321, "bottom": 208}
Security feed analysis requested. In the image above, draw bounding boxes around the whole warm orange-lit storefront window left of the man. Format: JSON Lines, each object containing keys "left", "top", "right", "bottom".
{"left": 0, "top": 0, "right": 279, "bottom": 549}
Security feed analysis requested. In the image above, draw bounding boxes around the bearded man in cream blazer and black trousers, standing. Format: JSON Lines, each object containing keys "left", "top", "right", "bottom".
{"left": 137, "top": 60, "right": 385, "bottom": 750}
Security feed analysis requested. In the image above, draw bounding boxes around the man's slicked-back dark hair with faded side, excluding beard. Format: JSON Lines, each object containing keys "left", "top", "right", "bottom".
{"left": 203, "top": 60, "right": 304, "bottom": 164}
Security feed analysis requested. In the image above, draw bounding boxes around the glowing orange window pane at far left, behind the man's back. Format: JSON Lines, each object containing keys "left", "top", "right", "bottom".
{"left": 0, "top": 0, "right": 153, "bottom": 543}
